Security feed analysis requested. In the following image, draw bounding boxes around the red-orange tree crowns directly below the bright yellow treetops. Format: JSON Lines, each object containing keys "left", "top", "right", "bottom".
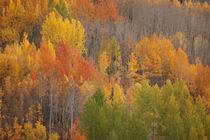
{"left": 56, "top": 43, "right": 94, "bottom": 85}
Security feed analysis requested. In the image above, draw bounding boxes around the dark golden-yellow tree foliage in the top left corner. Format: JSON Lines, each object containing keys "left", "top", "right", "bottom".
{"left": 0, "top": 0, "right": 27, "bottom": 44}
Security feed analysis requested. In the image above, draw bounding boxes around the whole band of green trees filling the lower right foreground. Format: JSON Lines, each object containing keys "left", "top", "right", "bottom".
{"left": 81, "top": 80, "right": 209, "bottom": 140}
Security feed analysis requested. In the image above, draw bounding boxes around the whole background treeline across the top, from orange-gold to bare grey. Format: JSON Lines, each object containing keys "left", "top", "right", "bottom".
{"left": 0, "top": 0, "right": 210, "bottom": 65}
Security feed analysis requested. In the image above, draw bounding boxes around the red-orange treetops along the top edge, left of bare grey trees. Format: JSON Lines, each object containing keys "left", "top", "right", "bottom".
{"left": 67, "top": 0, "right": 119, "bottom": 23}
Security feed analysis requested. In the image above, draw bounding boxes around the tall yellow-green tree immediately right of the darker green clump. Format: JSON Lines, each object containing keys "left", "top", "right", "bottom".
{"left": 133, "top": 81, "right": 162, "bottom": 139}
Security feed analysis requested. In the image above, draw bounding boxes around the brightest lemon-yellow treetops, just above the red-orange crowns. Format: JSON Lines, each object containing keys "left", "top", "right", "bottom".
{"left": 41, "top": 12, "right": 86, "bottom": 53}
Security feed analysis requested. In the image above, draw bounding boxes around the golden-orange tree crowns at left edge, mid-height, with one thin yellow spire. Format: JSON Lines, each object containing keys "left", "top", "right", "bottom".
{"left": 0, "top": 34, "right": 37, "bottom": 82}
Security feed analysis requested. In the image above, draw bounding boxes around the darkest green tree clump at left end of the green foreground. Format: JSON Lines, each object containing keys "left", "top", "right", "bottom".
{"left": 81, "top": 90, "right": 129, "bottom": 140}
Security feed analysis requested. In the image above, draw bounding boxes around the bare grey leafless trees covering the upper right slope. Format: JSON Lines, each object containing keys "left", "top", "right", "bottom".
{"left": 114, "top": 0, "right": 210, "bottom": 64}
